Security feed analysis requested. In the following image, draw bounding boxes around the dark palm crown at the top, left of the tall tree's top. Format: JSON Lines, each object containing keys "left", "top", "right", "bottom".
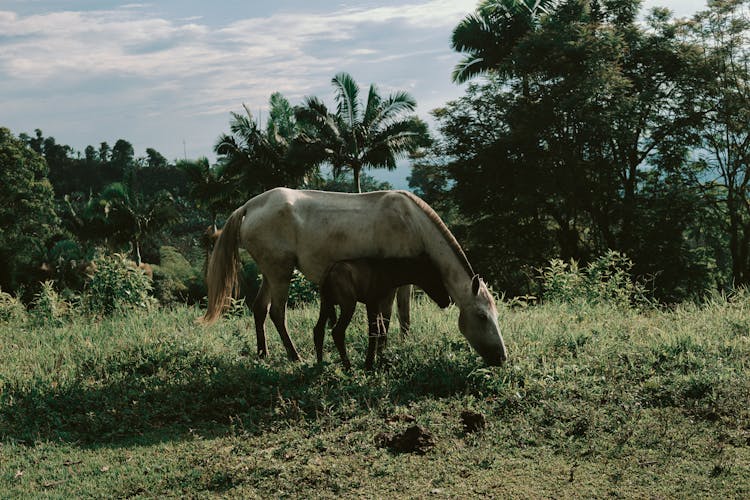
{"left": 451, "top": 0, "right": 561, "bottom": 91}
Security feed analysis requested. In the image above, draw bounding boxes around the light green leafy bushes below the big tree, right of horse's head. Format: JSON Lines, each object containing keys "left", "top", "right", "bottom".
{"left": 540, "top": 250, "right": 648, "bottom": 309}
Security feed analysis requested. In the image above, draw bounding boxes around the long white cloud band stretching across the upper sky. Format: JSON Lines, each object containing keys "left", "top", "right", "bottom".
{"left": 0, "top": 0, "right": 474, "bottom": 82}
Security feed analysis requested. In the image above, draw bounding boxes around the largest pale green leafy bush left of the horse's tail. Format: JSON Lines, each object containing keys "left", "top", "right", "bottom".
{"left": 83, "top": 254, "right": 152, "bottom": 315}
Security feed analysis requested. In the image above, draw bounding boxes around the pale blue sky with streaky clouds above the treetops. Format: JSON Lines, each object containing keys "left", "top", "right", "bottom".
{"left": 0, "top": 0, "right": 705, "bottom": 187}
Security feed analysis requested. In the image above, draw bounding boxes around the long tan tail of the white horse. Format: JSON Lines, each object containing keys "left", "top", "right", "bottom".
{"left": 201, "top": 207, "right": 245, "bottom": 324}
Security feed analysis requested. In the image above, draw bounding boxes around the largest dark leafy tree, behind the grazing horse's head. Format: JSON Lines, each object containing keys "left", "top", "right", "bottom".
{"left": 436, "top": 0, "right": 720, "bottom": 291}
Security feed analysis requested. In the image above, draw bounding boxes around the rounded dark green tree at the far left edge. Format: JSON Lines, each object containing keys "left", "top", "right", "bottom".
{"left": 0, "top": 128, "right": 58, "bottom": 291}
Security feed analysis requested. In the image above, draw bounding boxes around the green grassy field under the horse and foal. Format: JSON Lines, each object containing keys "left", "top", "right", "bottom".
{"left": 0, "top": 296, "right": 750, "bottom": 498}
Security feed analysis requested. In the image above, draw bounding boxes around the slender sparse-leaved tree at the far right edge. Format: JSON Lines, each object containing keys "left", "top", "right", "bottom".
{"left": 684, "top": 0, "right": 750, "bottom": 286}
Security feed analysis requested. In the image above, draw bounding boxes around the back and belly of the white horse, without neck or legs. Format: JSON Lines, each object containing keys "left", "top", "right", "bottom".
{"left": 242, "top": 188, "right": 424, "bottom": 283}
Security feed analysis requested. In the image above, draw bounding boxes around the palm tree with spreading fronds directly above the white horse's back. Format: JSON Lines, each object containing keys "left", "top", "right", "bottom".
{"left": 292, "top": 73, "right": 428, "bottom": 192}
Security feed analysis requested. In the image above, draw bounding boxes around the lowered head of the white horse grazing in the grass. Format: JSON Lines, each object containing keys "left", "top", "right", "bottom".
{"left": 458, "top": 275, "right": 508, "bottom": 366}
